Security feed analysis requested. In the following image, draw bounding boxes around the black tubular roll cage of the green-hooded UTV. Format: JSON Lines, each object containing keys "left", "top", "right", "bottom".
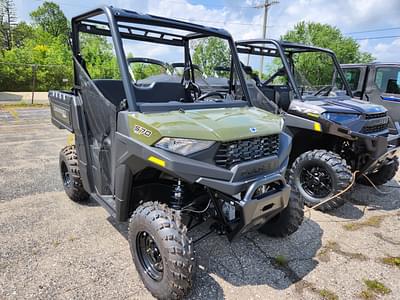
{"left": 71, "top": 6, "right": 251, "bottom": 111}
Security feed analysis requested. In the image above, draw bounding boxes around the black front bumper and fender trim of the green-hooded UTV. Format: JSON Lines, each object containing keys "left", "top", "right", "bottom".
{"left": 116, "top": 134, "right": 291, "bottom": 232}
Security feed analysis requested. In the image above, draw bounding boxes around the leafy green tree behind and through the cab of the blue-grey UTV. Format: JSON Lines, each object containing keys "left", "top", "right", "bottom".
{"left": 281, "top": 21, "right": 374, "bottom": 85}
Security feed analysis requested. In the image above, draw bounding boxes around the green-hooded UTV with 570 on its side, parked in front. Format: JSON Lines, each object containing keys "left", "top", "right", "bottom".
{"left": 49, "top": 7, "right": 303, "bottom": 299}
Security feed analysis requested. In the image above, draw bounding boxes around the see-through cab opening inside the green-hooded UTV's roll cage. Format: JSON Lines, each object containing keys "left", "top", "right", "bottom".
{"left": 75, "top": 11, "right": 249, "bottom": 111}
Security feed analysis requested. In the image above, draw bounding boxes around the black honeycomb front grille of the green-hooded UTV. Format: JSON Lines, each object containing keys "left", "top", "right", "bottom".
{"left": 214, "top": 134, "right": 279, "bottom": 169}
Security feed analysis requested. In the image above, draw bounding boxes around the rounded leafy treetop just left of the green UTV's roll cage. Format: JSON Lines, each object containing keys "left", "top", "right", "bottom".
{"left": 30, "top": 1, "right": 69, "bottom": 40}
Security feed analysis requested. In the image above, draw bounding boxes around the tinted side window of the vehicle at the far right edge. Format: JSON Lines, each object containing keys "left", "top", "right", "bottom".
{"left": 375, "top": 67, "right": 400, "bottom": 95}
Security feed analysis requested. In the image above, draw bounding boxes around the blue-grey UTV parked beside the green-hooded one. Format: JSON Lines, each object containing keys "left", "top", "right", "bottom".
{"left": 236, "top": 40, "right": 399, "bottom": 211}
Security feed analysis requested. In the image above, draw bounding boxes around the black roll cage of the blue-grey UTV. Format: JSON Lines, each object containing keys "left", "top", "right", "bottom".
{"left": 236, "top": 39, "right": 353, "bottom": 101}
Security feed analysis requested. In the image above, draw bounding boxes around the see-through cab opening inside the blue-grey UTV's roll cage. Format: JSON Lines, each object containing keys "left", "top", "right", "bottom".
{"left": 237, "top": 41, "right": 347, "bottom": 105}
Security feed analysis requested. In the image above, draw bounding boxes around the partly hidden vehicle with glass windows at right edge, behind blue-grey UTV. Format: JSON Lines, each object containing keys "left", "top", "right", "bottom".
{"left": 341, "top": 62, "right": 400, "bottom": 128}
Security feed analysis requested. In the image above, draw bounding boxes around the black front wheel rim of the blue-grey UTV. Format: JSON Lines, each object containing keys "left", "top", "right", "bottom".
{"left": 300, "top": 165, "right": 333, "bottom": 198}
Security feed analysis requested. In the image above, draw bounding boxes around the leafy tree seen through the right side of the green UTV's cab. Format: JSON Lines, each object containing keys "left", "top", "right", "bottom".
{"left": 193, "top": 37, "right": 231, "bottom": 76}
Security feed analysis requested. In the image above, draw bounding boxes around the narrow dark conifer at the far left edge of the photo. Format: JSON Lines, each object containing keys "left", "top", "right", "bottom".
{"left": 0, "top": 0, "right": 17, "bottom": 50}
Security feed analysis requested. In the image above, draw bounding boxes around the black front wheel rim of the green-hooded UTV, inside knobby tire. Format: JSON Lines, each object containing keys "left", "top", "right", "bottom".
{"left": 136, "top": 231, "right": 164, "bottom": 281}
